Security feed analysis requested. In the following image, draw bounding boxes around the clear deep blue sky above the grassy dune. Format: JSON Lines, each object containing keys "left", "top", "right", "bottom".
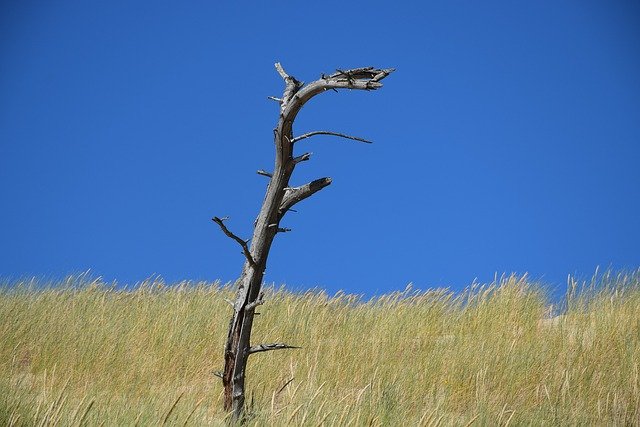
{"left": 0, "top": 1, "right": 640, "bottom": 294}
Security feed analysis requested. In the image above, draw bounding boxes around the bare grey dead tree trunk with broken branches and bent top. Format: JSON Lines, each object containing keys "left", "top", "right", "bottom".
{"left": 213, "top": 63, "right": 394, "bottom": 419}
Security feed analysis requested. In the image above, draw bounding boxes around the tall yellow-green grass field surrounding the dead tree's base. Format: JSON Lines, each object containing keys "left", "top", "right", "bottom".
{"left": 0, "top": 271, "right": 640, "bottom": 426}
